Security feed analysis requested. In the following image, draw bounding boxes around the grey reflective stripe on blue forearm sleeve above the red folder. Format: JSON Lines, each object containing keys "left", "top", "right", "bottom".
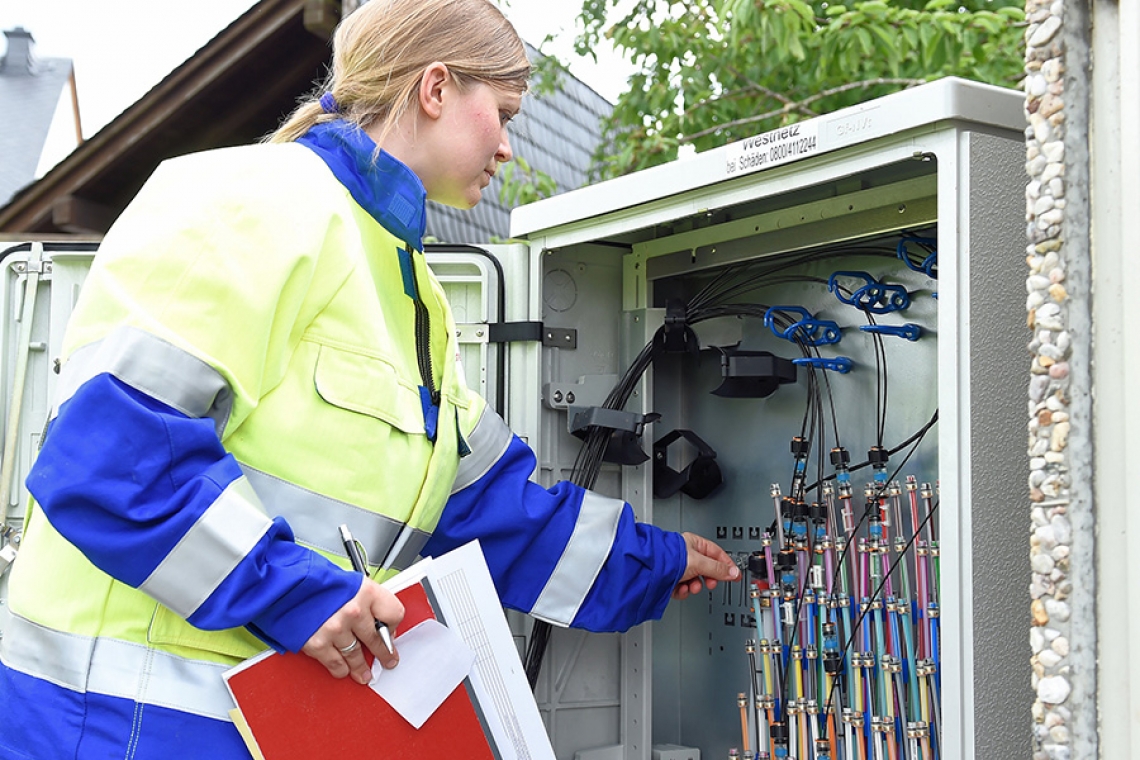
{"left": 139, "top": 477, "right": 272, "bottom": 618}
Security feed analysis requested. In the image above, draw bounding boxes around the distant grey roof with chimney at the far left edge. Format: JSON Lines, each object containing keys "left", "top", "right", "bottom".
{"left": 0, "top": 26, "right": 72, "bottom": 205}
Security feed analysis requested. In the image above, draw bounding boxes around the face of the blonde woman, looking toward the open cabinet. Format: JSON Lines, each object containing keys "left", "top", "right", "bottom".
{"left": 420, "top": 80, "right": 522, "bottom": 209}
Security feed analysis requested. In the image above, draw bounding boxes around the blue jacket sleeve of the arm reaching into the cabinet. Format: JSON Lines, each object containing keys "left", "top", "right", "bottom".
{"left": 423, "top": 435, "right": 687, "bottom": 631}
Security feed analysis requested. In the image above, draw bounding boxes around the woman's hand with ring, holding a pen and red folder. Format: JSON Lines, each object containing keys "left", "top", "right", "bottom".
{"left": 301, "top": 578, "right": 404, "bottom": 684}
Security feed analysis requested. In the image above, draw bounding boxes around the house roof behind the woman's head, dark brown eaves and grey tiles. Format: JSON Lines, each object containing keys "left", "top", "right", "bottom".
{"left": 0, "top": 0, "right": 612, "bottom": 243}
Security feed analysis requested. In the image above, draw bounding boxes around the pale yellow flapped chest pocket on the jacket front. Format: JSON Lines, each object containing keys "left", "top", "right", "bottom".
{"left": 315, "top": 345, "right": 424, "bottom": 435}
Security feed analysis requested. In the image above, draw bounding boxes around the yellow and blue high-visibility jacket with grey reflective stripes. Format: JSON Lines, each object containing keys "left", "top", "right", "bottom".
{"left": 0, "top": 122, "right": 685, "bottom": 758}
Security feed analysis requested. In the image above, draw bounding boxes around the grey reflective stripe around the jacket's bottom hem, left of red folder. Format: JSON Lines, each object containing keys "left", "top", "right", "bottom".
{"left": 0, "top": 614, "right": 234, "bottom": 721}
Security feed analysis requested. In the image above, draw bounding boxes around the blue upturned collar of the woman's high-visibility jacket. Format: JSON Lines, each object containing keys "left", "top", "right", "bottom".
{"left": 298, "top": 120, "right": 428, "bottom": 251}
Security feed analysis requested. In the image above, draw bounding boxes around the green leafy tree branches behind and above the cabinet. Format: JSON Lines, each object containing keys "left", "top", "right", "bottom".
{"left": 508, "top": 0, "right": 1026, "bottom": 199}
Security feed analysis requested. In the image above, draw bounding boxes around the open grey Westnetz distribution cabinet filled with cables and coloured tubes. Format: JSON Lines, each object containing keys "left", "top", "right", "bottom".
{"left": 0, "top": 80, "right": 1031, "bottom": 760}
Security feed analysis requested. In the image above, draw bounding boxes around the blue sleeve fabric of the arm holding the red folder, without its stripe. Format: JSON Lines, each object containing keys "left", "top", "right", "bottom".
{"left": 27, "top": 375, "right": 360, "bottom": 651}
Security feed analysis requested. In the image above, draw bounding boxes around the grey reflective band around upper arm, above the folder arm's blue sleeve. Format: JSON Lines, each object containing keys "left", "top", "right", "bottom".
{"left": 51, "top": 327, "right": 234, "bottom": 436}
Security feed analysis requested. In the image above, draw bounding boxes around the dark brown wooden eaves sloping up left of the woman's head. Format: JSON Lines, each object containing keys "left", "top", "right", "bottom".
{"left": 0, "top": 0, "right": 328, "bottom": 235}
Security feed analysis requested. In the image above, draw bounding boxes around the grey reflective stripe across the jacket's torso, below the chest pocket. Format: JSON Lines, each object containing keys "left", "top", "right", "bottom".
{"left": 242, "top": 464, "right": 428, "bottom": 566}
